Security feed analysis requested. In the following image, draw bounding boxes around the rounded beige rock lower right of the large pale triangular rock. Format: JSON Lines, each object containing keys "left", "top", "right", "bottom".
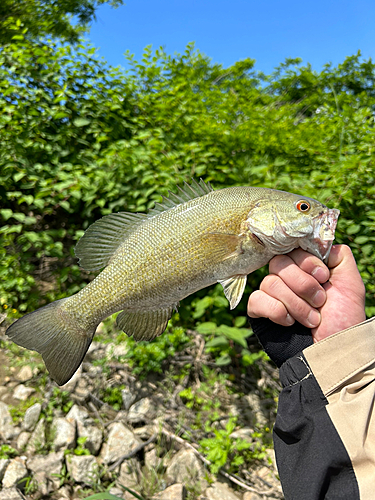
{"left": 166, "top": 449, "right": 207, "bottom": 488}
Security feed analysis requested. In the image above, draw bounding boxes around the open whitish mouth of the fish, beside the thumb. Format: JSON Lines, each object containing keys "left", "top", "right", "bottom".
{"left": 300, "top": 208, "right": 340, "bottom": 264}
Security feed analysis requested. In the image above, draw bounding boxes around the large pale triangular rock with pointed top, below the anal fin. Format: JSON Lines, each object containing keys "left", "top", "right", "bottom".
{"left": 102, "top": 422, "right": 142, "bottom": 464}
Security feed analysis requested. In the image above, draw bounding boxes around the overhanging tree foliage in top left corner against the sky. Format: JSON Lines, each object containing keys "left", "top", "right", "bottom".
{"left": 0, "top": 0, "right": 123, "bottom": 45}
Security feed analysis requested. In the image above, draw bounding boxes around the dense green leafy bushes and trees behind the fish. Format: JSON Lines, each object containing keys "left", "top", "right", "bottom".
{"left": 0, "top": 0, "right": 375, "bottom": 496}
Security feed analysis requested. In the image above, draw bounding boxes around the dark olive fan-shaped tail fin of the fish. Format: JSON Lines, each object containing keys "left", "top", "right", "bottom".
{"left": 6, "top": 299, "right": 96, "bottom": 385}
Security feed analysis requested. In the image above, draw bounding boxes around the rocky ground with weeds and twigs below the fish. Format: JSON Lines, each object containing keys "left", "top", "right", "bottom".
{"left": 0, "top": 320, "right": 282, "bottom": 500}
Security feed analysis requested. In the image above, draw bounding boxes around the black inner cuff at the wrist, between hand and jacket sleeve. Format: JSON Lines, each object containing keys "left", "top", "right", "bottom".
{"left": 249, "top": 318, "right": 313, "bottom": 368}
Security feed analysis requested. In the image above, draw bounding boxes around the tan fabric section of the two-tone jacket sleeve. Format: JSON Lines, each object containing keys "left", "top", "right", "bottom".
{"left": 303, "top": 318, "right": 375, "bottom": 500}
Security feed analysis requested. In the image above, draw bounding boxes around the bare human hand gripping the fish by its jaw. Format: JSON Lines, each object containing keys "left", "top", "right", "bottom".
{"left": 248, "top": 245, "right": 366, "bottom": 342}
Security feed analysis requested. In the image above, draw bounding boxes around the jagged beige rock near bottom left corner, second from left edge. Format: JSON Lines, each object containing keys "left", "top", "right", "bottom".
{"left": 27, "top": 451, "right": 64, "bottom": 495}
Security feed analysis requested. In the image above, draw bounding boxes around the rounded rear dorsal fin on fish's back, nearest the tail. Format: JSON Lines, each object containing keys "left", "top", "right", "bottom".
{"left": 75, "top": 212, "right": 147, "bottom": 271}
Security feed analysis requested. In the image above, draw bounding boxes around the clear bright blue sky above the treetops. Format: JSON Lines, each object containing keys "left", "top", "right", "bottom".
{"left": 88, "top": 0, "right": 375, "bottom": 73}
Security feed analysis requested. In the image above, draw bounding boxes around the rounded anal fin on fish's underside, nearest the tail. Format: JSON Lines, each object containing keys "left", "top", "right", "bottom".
{"left": 116, "top": 304, "right": 177, "bottom": 340}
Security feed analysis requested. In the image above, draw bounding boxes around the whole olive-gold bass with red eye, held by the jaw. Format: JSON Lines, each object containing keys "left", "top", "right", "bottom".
{"left": 6, "top": 179, "right": 340, "bottom": 385}
